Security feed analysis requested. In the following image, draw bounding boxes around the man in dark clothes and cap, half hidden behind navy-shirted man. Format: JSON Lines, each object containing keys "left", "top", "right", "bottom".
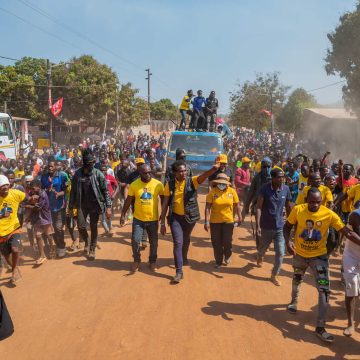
{"left": 241, "top": 157, "right": 272, "bottom": 249}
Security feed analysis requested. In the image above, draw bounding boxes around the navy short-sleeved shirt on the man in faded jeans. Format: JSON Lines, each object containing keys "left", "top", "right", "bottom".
{"left": 259, "top": 183, "right": 292, "bottom": 230}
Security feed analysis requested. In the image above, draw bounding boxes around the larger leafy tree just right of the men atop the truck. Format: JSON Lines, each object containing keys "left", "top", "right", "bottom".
{"left": 230, "top": 72, "right": 289, "bottom": 130}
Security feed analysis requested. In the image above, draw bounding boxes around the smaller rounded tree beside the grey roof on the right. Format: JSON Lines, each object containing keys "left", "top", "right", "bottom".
{"left": 276, "top": 88, "right": 317, "bottom": 132}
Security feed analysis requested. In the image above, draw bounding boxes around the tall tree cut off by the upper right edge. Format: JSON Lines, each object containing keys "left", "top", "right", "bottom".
{"left": 325, "top": 2, "right": 360, "bottom": 115}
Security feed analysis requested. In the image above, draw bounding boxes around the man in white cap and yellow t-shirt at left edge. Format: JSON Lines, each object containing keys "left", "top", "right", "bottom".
{"left": 0, "top": 175, "right": 25, "bottom": 285}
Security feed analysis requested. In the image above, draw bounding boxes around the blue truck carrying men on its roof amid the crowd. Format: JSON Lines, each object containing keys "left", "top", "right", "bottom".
{"left": 166, "top": 131, "right": 224, "bottom": 175}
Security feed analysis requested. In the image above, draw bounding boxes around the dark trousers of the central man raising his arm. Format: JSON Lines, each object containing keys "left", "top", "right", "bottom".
{"left": 170, "top": 214, "right": 195, "bottom": 273}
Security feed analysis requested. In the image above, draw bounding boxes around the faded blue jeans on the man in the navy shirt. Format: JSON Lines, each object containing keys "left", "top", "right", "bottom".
{"left": 258, "top": 228, "right": 285, "bottom": 275}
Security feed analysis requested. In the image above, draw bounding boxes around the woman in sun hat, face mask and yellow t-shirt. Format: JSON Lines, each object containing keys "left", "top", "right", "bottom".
{"left": 204, "top": 173, "right": 242, "bottom": 268}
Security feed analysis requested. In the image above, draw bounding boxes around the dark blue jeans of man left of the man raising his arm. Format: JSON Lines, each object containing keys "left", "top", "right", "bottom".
{"left": 131, "top": 218, "right": 159, "bottom": 264}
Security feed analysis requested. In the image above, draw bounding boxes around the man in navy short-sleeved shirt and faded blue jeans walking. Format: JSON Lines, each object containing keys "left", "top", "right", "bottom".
{"left": 256, "top": 168, "right": 292, "bottom": 286}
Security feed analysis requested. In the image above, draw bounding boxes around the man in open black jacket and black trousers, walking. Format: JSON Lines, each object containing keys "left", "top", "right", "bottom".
{"left": 69, "top": 149, "right": 111, "bottom": 260}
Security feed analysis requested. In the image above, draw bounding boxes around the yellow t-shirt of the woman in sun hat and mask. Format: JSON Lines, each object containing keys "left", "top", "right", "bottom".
{"left": 206, "top": 187, "right": 239, "bottom": 224}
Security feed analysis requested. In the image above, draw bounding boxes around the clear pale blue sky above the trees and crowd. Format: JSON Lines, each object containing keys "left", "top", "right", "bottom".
{"left": 0, "top": 0, "right": 356, "bottom": 112}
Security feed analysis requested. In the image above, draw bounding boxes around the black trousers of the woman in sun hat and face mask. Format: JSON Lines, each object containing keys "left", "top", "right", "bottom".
{"left": 210, "top": 223, "right": 234, "bottom": 265}
